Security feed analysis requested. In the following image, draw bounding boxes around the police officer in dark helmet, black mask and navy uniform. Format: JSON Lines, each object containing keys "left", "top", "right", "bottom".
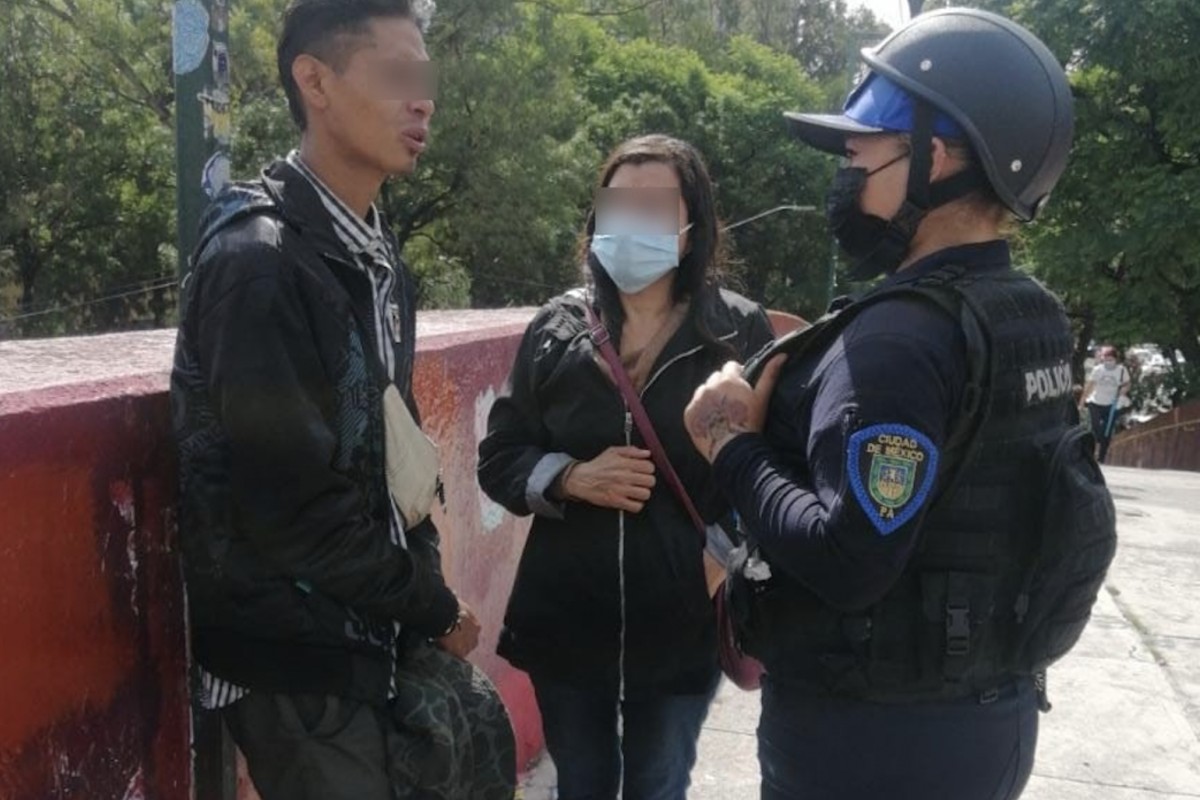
{"left": 685, "top": 8, "right": 1080, "bottom": 800}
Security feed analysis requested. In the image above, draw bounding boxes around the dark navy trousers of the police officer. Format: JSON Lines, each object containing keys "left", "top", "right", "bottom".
{"left": 758, "top": 680, "right": 1038, "bottom": 800}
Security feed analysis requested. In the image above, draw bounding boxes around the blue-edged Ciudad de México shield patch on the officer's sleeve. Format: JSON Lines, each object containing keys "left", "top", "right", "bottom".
{"left": 846, "top": 425, "right": 937, "bottom": 536}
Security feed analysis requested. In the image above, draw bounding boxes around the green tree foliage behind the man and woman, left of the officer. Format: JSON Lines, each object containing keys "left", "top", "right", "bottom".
{"left": 0, "top": 0, "right": 892, "bottom": 336}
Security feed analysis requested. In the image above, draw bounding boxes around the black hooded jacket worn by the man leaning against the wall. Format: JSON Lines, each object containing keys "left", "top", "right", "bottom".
{"left": 170, "top": 162, "right": 457, "bottom": 703}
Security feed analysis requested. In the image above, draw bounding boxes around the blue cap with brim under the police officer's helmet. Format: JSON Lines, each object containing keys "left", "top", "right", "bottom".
{"left": 784, "top": 72, "right": 966, "bottom": 155}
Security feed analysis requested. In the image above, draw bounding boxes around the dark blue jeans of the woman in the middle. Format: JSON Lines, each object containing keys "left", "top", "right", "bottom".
{"left": 533, "top": 678, "right": 718, "bottom": 800}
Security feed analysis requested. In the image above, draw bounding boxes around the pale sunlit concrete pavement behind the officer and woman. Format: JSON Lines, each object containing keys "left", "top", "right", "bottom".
{"left": 523, "top": 468, "right": 1200, "bottom": 800}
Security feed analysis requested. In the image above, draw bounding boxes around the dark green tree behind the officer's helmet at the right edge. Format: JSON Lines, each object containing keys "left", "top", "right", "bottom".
{"left": 1009, "top": 0, "right": 1200, "bottom": 381}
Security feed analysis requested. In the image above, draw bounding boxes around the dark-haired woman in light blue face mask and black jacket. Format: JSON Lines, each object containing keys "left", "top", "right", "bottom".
{"left": 479, "top": 136, "right": 772, "bottom": 800}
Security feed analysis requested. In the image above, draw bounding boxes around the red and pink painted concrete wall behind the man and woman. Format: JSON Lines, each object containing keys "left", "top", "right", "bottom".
{"left": 0, "top": 309, "right": 541, "bottom": 800}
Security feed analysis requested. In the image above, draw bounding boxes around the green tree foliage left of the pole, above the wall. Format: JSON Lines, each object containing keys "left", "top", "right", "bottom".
{"left": 0, "top": 0, "right": 174, "bottom": 335}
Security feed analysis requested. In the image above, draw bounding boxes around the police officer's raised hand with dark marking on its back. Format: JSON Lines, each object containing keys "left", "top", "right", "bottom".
{"left": 683, "top": 355, "right": 787, "bottom": 462}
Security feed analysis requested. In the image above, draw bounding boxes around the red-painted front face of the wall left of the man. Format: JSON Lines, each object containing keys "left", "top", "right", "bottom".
{"left": 0, "top": 371, "right": 191, "bottom": 800}
